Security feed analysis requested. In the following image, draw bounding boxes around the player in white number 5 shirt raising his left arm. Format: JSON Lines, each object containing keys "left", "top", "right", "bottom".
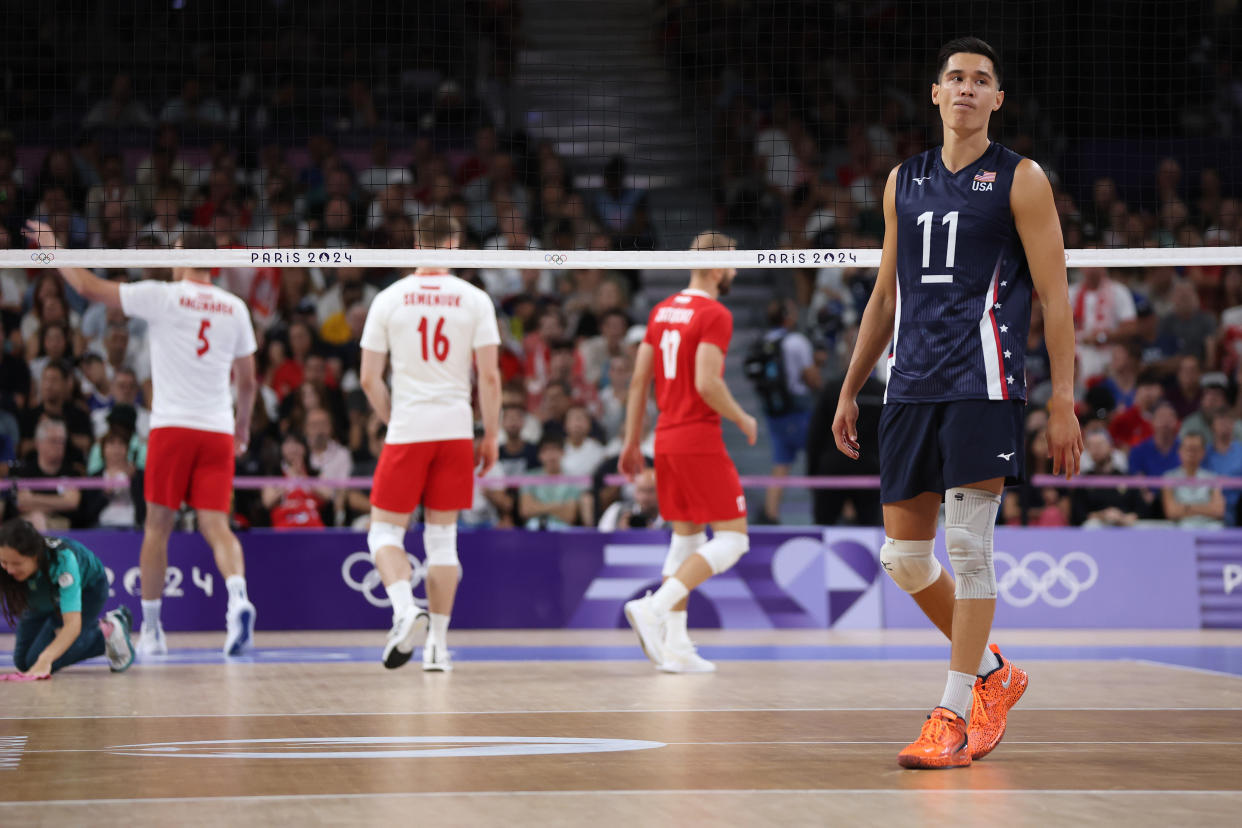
{"left": 27, "top": 222, "right": 258, "bottom": 657}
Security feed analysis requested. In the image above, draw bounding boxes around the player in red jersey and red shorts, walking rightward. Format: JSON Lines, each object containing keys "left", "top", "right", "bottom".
{"left": 619, "top": 231, "right": 758, "bottom": 673}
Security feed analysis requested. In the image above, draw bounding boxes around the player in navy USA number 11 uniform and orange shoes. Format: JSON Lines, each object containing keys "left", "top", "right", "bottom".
{"left": 832, "top": 37, "right": 1083, "bottom": 767}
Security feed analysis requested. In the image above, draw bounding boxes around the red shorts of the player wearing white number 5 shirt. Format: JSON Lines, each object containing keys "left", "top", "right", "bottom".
{"left": 143, "top": 426, "right": 233, "bottom": 513}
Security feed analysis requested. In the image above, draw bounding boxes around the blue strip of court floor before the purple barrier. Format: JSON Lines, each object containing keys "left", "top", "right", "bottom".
{"left": 9, "top": 644, "right": 1242, "bottom": 678}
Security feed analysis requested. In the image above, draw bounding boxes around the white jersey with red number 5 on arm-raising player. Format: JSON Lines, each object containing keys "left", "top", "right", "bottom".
{"left": 120, "top": 279, "right": 256, "bottom": 434}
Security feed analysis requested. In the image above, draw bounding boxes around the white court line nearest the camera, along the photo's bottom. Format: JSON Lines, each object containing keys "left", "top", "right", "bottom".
{"left": 0, "top": 788, "right": 1242, "bottom": 808}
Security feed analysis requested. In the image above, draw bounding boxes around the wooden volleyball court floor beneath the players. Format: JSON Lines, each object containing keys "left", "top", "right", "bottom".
{"left": 0, "top": 631, "right": 1242, "bottom": 827}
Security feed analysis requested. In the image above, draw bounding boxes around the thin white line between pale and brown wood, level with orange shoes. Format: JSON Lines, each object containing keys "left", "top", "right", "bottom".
{"left": 0, "top": 705, "right": 1242, "bottom": 721}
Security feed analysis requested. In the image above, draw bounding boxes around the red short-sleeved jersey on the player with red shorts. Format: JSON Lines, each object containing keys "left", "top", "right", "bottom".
{"left": 643, "top": 289, "right": 733, "bottom": 454}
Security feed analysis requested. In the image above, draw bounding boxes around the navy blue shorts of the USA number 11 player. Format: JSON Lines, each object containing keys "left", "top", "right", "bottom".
{"left": 879, "top": 400, "right": 1026, "bottom": 503}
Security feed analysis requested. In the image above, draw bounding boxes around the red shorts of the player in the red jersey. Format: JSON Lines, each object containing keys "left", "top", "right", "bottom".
{"left": 656, "top": 452, "right": 746, "bottom": 524}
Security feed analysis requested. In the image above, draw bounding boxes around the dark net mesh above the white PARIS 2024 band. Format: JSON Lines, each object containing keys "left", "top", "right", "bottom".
{"left": 0, "top": 0, "right": 1242, "bottom": 267}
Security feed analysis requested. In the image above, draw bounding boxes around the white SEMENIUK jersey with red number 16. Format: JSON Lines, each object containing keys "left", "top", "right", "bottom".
{"left": 361, "top": 273, "right": 501, "bottom": 443}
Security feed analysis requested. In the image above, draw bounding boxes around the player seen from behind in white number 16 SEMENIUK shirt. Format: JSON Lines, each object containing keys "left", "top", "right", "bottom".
{"left": 361, "top": 215, "right": 501, "bottom": 672}
